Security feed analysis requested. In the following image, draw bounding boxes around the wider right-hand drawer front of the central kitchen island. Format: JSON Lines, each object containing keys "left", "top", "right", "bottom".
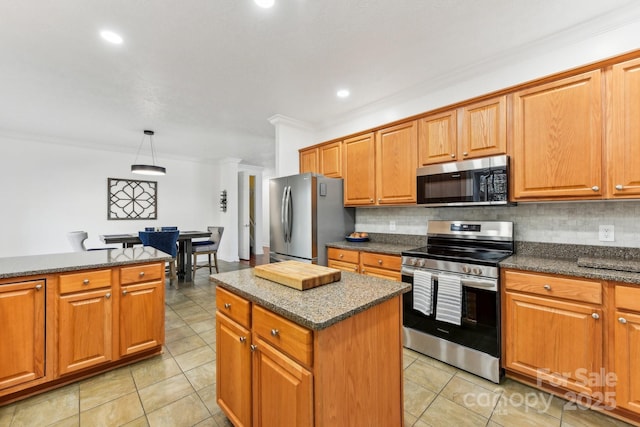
{"left": 253, "top": 306, "right": 313, "bottom": 366}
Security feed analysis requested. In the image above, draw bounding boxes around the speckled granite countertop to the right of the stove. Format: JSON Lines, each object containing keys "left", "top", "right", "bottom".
{"left": 500, "top": 242, "right": 640, "bottom": 285}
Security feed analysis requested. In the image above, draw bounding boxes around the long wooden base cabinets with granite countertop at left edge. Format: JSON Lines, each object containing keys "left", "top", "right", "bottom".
{"left": 0, "top": 247, "right": 171, "bottom": 405}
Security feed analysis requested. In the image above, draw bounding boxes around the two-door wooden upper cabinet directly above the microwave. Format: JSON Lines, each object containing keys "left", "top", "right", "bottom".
{"left": 418, "top": 96, "right": 507, "bottom": 166}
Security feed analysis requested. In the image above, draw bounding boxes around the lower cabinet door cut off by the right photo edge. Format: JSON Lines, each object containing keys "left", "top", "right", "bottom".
{"left": 614, "top": 311, "right": 640, "bottom": 413}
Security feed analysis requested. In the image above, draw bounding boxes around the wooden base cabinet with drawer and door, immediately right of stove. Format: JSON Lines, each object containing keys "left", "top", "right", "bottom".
{"left": 502, "top": 270, "right": 604, "bottom": 396}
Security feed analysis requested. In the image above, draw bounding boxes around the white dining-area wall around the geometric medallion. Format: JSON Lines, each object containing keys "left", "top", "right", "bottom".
{"left": 0, "top": 135, "right": 225, "bottom": 259}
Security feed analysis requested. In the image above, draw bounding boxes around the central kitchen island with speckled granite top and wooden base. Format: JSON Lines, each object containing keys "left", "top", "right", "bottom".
{"left": 211, "top": 269, "right": 410, "bottom": 426}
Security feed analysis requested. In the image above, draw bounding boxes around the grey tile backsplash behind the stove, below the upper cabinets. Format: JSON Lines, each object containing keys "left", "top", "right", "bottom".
{"left": 356, "top": 200, "right": 640, "bottom": 247}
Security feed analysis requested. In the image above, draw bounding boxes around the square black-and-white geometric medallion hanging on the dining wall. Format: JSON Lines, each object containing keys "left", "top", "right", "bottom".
{"left": 107, "top": 178, "right": 158, "bottom": 219}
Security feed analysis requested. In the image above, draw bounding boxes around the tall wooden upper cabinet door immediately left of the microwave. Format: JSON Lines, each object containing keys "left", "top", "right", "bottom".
{"left": 376, "top": 121, "right": 418, "bottom": 205}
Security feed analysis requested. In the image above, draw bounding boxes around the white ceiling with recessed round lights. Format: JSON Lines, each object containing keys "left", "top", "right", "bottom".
{"left": 0, "top": 0, "right": 640, "bottom": 168}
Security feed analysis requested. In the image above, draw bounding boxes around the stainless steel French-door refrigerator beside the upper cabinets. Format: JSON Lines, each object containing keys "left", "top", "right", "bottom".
{"left": 269, "top": 173, "right": 355, "bottom": 265}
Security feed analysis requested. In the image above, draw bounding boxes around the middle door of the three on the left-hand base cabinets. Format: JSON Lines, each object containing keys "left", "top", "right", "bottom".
{"left": 58, "top": 288, "right": 113, "bottom": 375}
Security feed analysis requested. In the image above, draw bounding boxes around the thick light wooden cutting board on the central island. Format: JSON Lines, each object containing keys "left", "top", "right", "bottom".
{"left": 254, "top": 261, "right": 341, "bottom": 291}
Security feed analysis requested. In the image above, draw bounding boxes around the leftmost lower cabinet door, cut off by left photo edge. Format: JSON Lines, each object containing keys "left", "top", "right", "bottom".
{"left": 0, "top": 280, "right": 45, "bottom": 390}
